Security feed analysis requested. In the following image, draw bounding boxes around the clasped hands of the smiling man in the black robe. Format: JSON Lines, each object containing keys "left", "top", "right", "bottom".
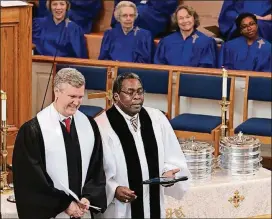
{"left": 65, "top": 198, "right": 90, "bottom": 218}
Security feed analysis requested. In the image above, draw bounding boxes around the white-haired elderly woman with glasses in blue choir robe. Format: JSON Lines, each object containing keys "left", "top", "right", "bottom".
{"left": 98, "top": 1, "right": 154, "bottom": 63}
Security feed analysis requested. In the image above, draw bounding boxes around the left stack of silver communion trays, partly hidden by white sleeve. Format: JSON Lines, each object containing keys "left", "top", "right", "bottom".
{"left": 179, "top": 139, "right": 214, "bottom": 180}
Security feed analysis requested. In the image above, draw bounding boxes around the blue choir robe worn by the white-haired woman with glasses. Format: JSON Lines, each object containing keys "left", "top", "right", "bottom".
{"left": 98, "top": 24, "right": 154, "bottom": 63}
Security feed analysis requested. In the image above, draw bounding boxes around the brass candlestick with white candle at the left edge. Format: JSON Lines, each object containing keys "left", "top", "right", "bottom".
{"left": 0, "top": 91, "right": 11, "bottom": 193}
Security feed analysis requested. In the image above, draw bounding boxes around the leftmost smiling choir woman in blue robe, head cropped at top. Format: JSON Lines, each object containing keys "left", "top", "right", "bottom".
{"left": 32, "top": 0, "right": 87, "bottom": 58}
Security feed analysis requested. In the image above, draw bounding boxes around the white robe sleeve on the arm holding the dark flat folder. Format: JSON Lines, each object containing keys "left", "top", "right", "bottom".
{"left": 159, "top": 112, "right": 191, "bottom": 199}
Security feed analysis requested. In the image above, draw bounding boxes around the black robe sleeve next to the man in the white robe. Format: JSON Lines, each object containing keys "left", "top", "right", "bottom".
{"left": 82, "top": 117, "right": 107, "bottom": 213}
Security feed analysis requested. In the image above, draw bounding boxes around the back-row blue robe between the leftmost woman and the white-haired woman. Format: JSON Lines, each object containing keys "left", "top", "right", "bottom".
{"left": 68, "top": 0, "right": 102, "bottom": 34}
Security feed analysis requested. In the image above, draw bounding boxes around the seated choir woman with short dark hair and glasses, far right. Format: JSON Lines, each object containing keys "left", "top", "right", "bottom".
{"left": 219, "top": 13, "right": 272, "bottom": 72}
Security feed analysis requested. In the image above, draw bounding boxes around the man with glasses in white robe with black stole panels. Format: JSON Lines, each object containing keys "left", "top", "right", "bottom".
{"left": 95, "top": 73, "right": 191, "bottom": 219}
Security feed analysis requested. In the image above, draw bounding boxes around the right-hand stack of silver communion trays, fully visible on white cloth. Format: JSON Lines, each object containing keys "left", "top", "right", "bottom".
{"left": 218, "top": 132, "right": 262, "bottom": 176}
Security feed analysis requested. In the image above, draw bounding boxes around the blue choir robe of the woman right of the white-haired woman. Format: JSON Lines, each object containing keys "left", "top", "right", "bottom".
{"left": 154, "top": 30, "right": 217, "bottom": 68}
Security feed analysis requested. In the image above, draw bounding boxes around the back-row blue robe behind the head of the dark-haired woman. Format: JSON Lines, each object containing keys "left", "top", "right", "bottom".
{"left": 218, "top": 0, "right": 272, "bottom": 42}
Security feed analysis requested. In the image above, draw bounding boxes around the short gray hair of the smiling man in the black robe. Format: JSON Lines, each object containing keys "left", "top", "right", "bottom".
{"left": 54, "top": 68, "right": 85, "bottom": 90}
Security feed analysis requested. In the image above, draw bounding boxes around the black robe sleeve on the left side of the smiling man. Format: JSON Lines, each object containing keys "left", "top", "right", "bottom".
{"left": 12, "top": 118, "right": 71, "bottom": 219}
